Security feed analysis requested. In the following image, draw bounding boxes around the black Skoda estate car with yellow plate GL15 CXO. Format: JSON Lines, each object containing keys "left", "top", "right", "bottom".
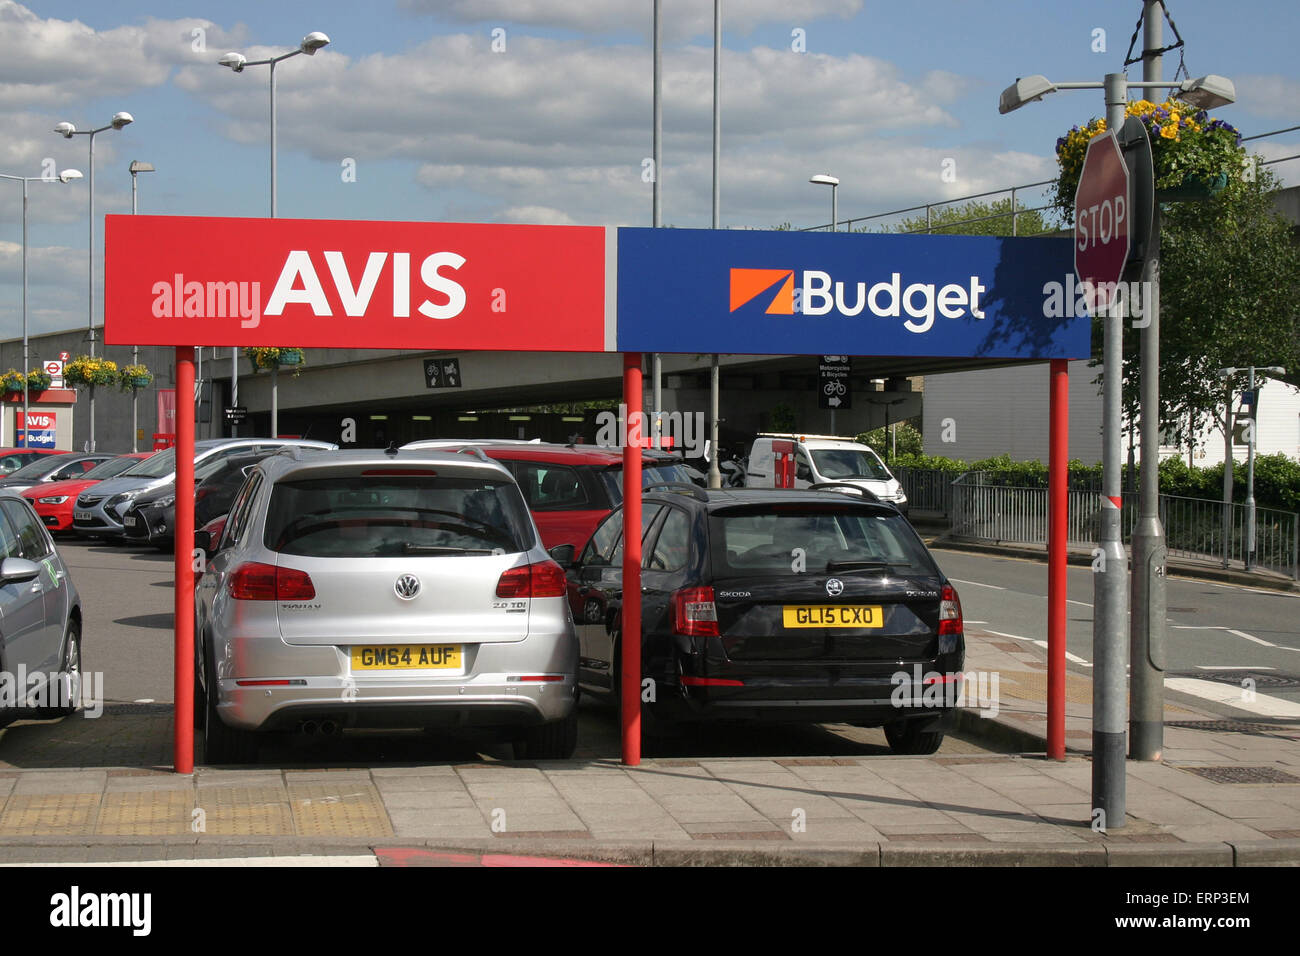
{"left": 551, "top": 485, "right": 966, "bottom": 753}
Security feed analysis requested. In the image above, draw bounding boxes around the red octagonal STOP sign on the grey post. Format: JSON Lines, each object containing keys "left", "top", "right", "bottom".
{"left": 1074, "top": 130, "right": 1131, "bottom": 315}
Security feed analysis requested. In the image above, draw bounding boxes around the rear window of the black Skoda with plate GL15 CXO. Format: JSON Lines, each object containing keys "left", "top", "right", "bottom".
{"left": 710, "top": 506, "right": 937, "bottom": 576}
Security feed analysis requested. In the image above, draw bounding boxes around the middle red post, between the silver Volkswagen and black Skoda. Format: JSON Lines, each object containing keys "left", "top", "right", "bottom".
{"left": 619, "top": 352, "right": 645, "bottom": 767}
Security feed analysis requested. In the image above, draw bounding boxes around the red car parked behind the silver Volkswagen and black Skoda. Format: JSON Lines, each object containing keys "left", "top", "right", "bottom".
{"left": 404, "top": 440, "right": 693, "bottom": 554}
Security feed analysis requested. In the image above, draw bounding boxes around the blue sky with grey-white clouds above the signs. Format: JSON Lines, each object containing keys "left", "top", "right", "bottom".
{"left": 0, "top": 0, "right": 1300, "bottom": 338}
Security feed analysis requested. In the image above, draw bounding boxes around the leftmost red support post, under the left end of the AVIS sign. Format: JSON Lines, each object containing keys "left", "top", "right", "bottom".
{"left": 173, "top": 346, "right": 194, "bottom": 774}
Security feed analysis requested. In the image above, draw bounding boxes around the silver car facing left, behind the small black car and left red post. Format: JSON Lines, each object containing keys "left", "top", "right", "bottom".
{"left": 73, "top": 438, "right": 338, "bottom": 537}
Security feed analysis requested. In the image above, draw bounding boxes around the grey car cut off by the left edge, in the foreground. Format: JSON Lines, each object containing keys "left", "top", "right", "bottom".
{"left": 0, "top": 490, "right": 82, "bottom": 726}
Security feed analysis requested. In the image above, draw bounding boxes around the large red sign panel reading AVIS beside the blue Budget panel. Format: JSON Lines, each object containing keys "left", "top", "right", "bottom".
{"left": 104, "top": 216, "right": 606, "bottom": 351}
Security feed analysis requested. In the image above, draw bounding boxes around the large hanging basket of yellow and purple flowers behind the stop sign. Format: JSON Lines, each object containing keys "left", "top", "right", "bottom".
{"left": 1052, "top": 100, "right": 1245, "bottom": 221}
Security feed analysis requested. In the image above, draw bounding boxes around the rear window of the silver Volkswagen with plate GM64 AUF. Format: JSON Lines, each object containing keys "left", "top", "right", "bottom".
{"left": 264, "top": 475, "right": 534, "bottom": 558}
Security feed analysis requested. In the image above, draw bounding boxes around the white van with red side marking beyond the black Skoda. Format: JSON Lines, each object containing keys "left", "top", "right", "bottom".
{"left": 745, "top": 432, "right": 907, "bottom": 514}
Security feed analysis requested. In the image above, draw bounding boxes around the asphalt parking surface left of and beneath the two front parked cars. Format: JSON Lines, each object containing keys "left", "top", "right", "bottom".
{"left": 0, "top": 538, "right": 993, "bottom": 770}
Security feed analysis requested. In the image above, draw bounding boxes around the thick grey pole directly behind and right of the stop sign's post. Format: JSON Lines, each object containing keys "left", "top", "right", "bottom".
{"left": 1117, "top": 0, "right": 1167, "bottom": 760}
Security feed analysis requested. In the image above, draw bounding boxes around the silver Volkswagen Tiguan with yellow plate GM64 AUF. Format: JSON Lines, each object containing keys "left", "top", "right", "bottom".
{"left": 195, "top": 449, "right": 579, "bottom": 763}
